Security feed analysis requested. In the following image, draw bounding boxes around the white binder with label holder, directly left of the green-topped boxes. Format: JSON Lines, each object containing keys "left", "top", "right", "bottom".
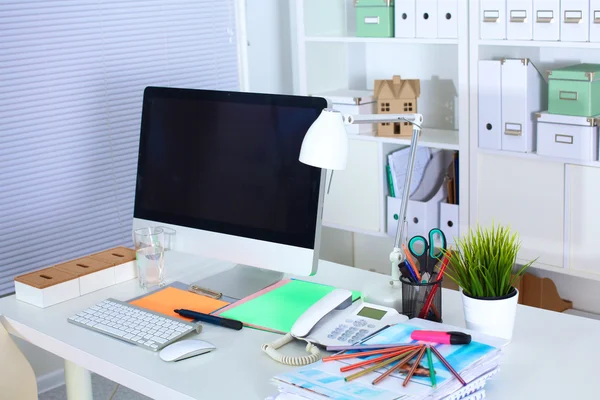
{"left": 501, "top": 58, "right": 548, "bottom": 153}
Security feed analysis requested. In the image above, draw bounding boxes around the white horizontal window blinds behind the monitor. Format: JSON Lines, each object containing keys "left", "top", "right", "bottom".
{"left": 0, "top": 0, "right": 239, "bottom": 295}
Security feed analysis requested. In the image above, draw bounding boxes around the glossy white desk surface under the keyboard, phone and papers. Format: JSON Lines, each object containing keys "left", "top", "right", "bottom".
{"left": 0, "top": 253, "right": 600, "bottom": 400}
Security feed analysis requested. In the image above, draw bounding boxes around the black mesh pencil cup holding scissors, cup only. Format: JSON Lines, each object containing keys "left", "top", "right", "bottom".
{"left": 400, "top": 276, "right": 443, "bottom": 322}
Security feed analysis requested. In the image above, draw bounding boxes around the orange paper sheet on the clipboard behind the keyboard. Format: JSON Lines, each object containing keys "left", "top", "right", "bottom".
{"left": 131, "top": 287, "right": 229, "bottom": 321}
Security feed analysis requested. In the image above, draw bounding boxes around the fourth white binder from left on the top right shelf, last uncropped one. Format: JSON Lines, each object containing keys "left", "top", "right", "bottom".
{"left": 560, "top": 0, "right": 590, "bottom": 42}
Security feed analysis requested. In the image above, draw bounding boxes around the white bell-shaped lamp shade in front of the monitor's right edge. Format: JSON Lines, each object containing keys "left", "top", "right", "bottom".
{"left": 300, "top": 108, "right": 348, "bottom": 169}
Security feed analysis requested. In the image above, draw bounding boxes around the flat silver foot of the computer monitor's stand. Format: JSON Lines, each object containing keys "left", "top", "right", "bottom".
{"left": 194, "top": 264, "right": 283, "bottom": 300}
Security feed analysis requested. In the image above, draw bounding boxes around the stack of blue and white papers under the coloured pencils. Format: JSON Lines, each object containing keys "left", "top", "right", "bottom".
{"left": 273, "top": 319, "right": 505, "bottom": 400}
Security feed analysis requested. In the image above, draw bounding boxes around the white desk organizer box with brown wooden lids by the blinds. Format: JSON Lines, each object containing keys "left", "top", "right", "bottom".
{"left": 15, "top": 247, "right": 137, "bottom": 308}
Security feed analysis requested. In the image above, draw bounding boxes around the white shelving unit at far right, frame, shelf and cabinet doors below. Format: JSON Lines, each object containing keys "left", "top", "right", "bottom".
{"left": 468, "top": 1, "right": 600, "bottom": 280}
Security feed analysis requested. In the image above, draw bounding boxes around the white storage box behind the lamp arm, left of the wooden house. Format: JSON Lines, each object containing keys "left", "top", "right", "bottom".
{"left": 313, "top": 89, "right": 376, "bottom": 135}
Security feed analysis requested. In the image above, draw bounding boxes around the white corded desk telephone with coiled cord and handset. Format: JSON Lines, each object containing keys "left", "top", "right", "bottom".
{"left": 262, "top": 289, "right": 408, "bottom": 365}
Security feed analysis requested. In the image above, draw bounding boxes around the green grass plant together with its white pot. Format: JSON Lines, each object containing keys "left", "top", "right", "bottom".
{"left": 446, "top": 226, "right": 535, "bottom": 340}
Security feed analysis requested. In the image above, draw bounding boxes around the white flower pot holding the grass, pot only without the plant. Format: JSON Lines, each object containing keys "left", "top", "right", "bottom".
{"left": 461, "top": 289, "right": 519, "bottom": 341}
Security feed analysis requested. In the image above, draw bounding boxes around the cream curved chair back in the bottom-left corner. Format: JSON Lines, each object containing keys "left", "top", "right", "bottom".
{"left": 0, "top": 316, "right": 38, "bottom": 400}
